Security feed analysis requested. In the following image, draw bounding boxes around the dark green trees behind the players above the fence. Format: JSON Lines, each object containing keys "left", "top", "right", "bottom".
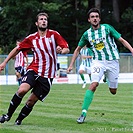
{"left": 0, "top": 0, "right": 133, "bottom": 54}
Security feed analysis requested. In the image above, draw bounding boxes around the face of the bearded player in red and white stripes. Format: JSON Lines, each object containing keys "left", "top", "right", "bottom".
{"left": 36, "top": 15, "right": 48, "bottom": 31}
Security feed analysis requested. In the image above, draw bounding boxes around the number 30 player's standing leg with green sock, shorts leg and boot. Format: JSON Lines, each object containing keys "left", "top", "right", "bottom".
{"left": 77, "top": 63, "right": 104, "bottom": 123}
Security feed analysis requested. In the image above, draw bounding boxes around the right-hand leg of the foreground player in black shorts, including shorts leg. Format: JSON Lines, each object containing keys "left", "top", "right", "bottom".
{"left": 15, "top": 77, "right": 53, "bottom": 125}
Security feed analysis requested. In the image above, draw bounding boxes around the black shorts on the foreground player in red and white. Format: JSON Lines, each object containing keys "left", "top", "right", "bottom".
{"left": 22, "top": 70, "right": 53, "bottom": 101}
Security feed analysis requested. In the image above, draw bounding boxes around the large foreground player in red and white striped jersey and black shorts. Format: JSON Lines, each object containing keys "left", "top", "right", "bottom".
{"left": 0, "top": 13, "right": 69, "bottom": 125}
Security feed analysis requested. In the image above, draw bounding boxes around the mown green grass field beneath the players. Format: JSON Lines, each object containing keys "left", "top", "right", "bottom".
{"left": 0, "top": 84, "right": 133, "bottom": 133}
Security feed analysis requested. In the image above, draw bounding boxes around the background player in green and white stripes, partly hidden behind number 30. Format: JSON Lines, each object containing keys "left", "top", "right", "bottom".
{"left": 78, "top": 45, "right": 92, "bottom": 88}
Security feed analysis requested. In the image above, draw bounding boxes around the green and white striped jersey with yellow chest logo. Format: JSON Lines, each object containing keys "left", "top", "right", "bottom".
{"left": 78, "top": 24, "right": 121, "bottom": 60}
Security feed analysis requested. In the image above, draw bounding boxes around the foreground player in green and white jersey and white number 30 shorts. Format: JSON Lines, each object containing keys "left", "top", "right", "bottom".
{"left": 67, "top": 8, "right": 133, "bottom": 123}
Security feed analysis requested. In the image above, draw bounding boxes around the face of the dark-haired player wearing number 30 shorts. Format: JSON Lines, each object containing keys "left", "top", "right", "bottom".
{"left": 88, "top": 12, "right": 101, "bottom": 28}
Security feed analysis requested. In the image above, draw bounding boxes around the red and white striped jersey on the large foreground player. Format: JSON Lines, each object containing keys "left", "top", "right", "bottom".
{"left": 18, "top": 29, "right": 68, "bottom": 78}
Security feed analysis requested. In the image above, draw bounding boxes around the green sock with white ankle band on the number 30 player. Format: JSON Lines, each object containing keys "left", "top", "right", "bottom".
{"left": 82, "top": 90, "right": 94, "bottom": 116}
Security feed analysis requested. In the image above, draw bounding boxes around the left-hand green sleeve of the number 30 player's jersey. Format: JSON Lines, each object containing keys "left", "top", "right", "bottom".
{"left": 78, "top": 31, "right": 89, "bottom": 48}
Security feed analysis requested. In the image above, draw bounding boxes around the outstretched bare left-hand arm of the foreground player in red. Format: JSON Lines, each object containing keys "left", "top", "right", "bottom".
{"left": 0, "top": 47, "right": 19, "bottom": 72}
